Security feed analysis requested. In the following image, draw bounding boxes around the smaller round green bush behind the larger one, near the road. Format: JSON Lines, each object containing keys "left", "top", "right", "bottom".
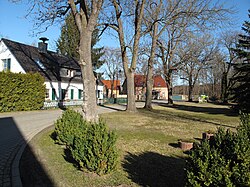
{"left": 54, "top": 109, "right": 87, "bottom": 146}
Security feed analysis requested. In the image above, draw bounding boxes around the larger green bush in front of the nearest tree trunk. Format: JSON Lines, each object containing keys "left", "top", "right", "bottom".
{"left": 70, "top": 121, "right": 118, "bottom": 175}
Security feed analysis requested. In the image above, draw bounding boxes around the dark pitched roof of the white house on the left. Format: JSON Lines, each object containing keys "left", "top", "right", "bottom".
{"left": 2, "top": 38, "right": 82, "bottom": 82}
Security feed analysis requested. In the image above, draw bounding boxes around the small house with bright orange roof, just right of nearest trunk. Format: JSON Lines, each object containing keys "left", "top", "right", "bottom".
{"left": 102, "top": 80, "right": 121, "bottom": 98}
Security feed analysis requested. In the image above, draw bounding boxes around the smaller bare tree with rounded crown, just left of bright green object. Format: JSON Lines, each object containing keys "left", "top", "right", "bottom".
{"left": 177, "top": 34, "right": 217, "bottom": 101}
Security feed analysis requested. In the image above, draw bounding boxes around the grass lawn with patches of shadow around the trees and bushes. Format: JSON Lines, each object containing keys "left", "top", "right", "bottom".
{"left": 21, "top": 102, "right": 239, "bottom": 187}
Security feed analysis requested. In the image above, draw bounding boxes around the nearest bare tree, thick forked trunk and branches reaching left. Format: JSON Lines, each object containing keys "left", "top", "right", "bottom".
{"left": 18, "top": 0, "right": 104, "bottom": 121}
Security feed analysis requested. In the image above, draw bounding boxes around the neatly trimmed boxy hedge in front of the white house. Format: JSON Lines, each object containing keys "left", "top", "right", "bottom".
{"left": 0, "top": 72, "right": 45, "bottom": 112}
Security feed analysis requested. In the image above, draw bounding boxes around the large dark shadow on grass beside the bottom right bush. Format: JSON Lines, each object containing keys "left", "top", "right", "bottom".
{"left": 122, "top": 152, "right": 185, "bottom": 187}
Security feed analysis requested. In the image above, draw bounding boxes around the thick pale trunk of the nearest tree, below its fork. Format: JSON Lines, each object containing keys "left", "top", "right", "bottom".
{"left": 79, "top": 32, "right": 98, "bottom": 121}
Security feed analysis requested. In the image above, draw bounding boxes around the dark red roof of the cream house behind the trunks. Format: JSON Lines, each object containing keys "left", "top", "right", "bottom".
{"left": 134, "top": 74, "right": 167, "bottom": 87}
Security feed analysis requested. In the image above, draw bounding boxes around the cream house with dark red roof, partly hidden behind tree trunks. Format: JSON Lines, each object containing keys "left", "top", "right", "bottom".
{"left": 123, "top": 74, "right": 168, "bottom": 100}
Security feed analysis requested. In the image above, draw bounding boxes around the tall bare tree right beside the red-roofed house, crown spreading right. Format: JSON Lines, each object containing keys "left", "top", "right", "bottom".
{"left": 157, "top": 0, "right": 233, "bottom": 104}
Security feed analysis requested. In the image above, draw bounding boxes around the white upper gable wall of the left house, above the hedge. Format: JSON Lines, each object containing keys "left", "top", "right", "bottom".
{"left": 0, "top": 41, "right": 25, "bottom": 73}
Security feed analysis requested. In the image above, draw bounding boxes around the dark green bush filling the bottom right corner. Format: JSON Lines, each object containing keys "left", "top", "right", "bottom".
{"left": 186, "top": 114, "right": 250, "bottom": 186}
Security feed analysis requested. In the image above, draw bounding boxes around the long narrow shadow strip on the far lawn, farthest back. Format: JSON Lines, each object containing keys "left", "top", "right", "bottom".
{"left": 159, "top": 103, "right": 239, "bottom": 116}
